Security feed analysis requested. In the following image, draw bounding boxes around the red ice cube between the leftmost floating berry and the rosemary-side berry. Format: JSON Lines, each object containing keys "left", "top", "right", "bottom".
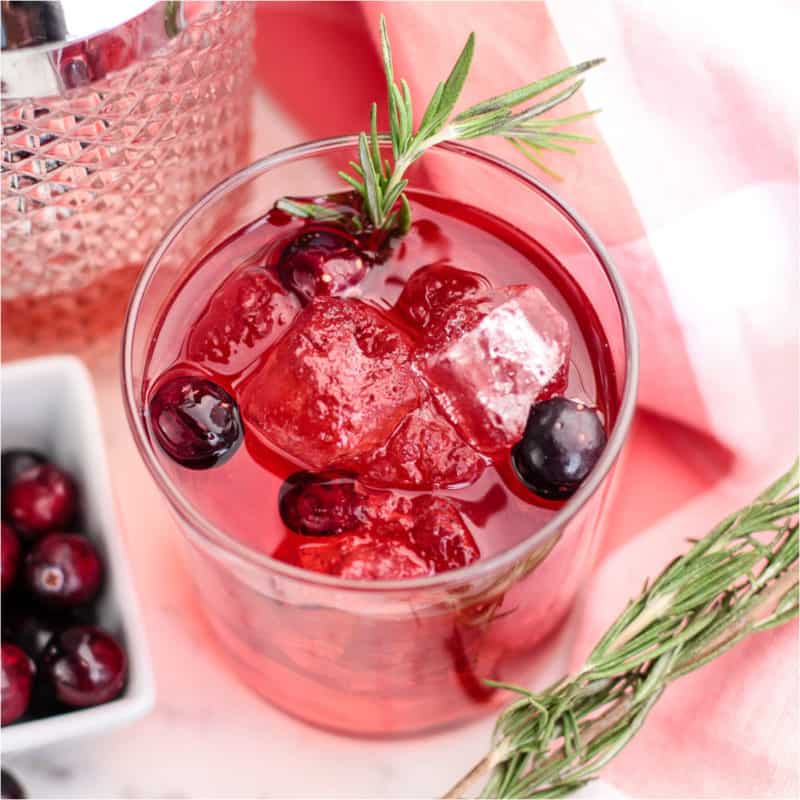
{"left": 186, "top": 266, "right": 300, "bottom": 373}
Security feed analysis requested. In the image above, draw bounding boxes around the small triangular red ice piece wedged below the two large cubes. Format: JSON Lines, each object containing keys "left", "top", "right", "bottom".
{"left": 360, "top": 401, "right": 484, "bottom": 489}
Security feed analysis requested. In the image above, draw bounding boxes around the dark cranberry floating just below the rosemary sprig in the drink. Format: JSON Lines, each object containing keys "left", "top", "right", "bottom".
{"left": 278, "top": 228, "right": 367, "bottom": 304}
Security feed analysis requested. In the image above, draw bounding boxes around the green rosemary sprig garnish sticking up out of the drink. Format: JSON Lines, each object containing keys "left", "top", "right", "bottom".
{"left": 277, "top": 16, "right": 604, "bottom": 233}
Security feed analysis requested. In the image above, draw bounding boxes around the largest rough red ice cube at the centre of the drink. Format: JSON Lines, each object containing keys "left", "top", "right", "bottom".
{"left": 241, "top": 297, "right": 420, "bottom": 469}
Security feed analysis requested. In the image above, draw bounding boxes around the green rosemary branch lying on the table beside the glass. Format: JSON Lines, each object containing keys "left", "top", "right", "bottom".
{"left": 445, "top": 462, "right": 798, "bottom": 798}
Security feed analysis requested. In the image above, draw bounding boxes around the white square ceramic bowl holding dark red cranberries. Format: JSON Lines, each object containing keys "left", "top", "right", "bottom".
{"left": 0, "top": 356, "right": 154, "bottom": 753}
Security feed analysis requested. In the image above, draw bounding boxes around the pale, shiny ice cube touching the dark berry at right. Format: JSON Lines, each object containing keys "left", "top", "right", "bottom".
{"left": 420, "top": 286, "right": 570, "bottom": 453}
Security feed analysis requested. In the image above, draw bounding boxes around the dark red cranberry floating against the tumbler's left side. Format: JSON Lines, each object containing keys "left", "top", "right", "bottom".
{"left": 150, "top": 375, "right": 243, "bottom": 469}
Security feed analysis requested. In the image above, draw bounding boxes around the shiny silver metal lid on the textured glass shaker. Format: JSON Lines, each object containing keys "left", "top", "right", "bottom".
{"left": 0, "top": 0, "right": 212, "bottom": 100}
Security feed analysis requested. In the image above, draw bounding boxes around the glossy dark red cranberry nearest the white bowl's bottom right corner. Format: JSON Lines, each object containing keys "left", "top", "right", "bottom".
{"left": 41, "top": 625, "right": 127, "bottom": 708}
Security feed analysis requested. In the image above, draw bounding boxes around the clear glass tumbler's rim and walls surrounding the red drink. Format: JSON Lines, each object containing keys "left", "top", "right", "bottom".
{"left": 123, "top": 137, "right": 638, "bottom": 735}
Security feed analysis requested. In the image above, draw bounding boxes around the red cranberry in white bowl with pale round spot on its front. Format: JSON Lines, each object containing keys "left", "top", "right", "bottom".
{"left": 25, "top": 533, "right": 103, "bottom": 608}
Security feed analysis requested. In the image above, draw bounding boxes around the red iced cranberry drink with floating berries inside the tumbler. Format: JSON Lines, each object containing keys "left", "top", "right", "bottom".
{"left": 126, "top": 18, "right": 636, "bottom": 734}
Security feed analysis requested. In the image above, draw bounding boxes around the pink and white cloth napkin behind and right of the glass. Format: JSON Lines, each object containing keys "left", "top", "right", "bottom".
{"left": 257, "top": 0, "right": 800, "bottom": 797}
